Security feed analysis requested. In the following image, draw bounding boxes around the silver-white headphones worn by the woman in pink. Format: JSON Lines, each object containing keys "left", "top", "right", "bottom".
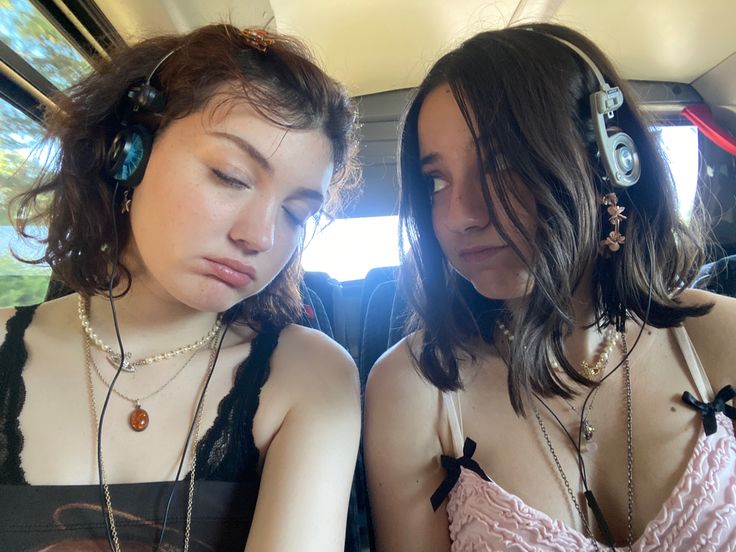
{"left": 545, "top": 34, "right": 641, "bottom": 188}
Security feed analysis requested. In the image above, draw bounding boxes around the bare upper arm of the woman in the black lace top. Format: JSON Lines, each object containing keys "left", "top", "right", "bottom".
{"left": 245, "top": 328, "right": 360, "bottom": 552}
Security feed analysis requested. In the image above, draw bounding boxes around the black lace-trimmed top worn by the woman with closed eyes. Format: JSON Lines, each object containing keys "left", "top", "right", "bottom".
{"left": 0, "top": 307, "right": 279, "bottom": 551}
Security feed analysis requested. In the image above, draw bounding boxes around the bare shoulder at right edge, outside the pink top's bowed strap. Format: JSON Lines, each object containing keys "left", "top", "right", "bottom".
{"left": 680, "top": 289, "right": 736, "bottom": 391}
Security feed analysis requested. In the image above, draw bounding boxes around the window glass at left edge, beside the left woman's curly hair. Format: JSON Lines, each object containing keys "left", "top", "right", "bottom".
{"left": 0, "top": 101, "right": 51, "bottom": 307}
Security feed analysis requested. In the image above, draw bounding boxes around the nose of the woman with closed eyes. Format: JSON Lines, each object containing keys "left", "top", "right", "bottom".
{"left": 230, "top": 195, "right": 280, "bottom": 252}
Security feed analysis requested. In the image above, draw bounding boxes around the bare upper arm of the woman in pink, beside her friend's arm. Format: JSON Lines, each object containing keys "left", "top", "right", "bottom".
{"left": 364, "top": 341, "right": 450, "bottom": 552}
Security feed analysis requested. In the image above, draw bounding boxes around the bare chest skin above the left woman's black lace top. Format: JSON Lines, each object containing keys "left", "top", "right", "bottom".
{"left": 18, "top": 330, "right": 262, "bottom": 484}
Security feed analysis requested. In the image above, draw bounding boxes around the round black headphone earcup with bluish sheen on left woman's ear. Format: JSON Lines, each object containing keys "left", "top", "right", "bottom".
{"left": 105, "top": 125, "right": 153, "bottom": 188}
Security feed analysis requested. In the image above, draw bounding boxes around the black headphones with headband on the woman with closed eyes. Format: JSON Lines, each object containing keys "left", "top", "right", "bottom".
{"left": 105, "top": 48, "right": 178, "bottom": 188}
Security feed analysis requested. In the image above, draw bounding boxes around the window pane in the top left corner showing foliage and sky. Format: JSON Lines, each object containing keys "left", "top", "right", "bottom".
{"left": 0, "top": 0, "right": 90, "bottom": 90}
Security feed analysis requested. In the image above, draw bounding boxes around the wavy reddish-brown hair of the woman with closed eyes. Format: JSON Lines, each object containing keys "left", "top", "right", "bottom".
{"left": 17, "top": 24, "right": 358, "bottom": 325}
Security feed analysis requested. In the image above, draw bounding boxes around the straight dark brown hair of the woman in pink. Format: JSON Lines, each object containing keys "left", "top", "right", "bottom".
{"left": 399, "top": 24, "right": 710, "bottom": 413}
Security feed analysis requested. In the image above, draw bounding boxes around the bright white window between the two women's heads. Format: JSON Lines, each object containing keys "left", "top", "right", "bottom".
{"left": 302, "top": 216, "right": 399, "bottom": 282}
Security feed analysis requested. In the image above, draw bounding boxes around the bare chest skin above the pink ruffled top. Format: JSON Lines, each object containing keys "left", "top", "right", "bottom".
{"left": 452, "top": 332, "right": 702, "bottom": 542}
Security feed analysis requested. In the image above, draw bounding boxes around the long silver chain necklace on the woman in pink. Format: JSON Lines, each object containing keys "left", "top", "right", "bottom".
{"left": 532, "top": 334, "right": 634, "bottom": 552}
